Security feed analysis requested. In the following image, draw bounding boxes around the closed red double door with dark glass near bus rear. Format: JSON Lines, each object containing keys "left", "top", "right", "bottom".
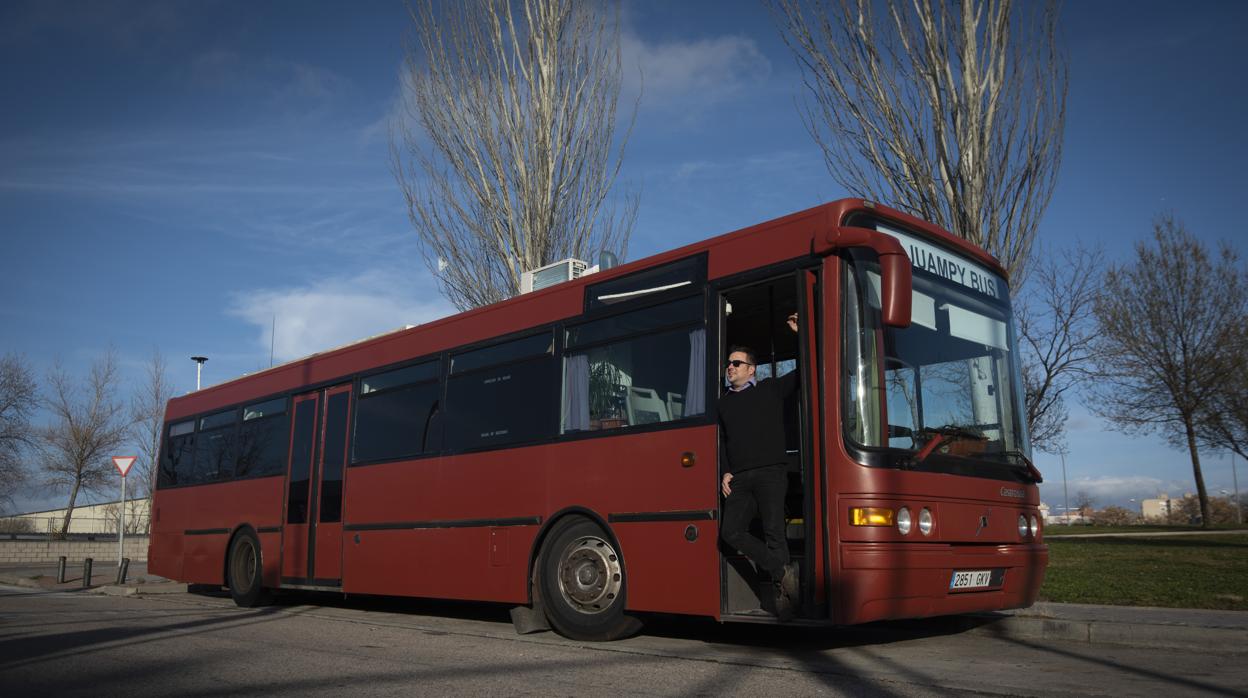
{"left": 282, "top": 383, "right": 351, "bottom": 587}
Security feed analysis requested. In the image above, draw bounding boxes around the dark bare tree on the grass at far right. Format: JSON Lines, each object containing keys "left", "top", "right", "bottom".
{"left": 1091, "top": 216, "right": 1248, "bottom": 527}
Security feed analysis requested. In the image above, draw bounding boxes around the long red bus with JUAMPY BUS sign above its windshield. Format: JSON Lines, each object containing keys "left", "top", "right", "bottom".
{"left": 149, "top": 200, "right": 1048, "bottom": 639}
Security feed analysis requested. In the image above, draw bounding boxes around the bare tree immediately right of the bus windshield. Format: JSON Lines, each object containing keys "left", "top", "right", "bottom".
{"left": 1015, "top": 246, "right": 1104, "bottom": 453}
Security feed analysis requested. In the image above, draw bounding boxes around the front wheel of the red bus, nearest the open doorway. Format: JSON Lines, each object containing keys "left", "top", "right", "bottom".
{"left": 535, "top": 517, "right": 641, "bottom": 642}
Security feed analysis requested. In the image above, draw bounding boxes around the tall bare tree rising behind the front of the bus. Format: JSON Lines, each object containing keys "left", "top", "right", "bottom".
{"left": 771, "top": 0, "right": 1067, "bottom": 287}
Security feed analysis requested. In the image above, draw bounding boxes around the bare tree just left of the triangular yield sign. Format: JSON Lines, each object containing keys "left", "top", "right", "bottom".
{"left": 37, "top": 350, "right": 130, "bottom": 536}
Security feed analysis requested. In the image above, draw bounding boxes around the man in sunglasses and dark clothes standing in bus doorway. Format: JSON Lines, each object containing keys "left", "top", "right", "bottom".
{"left": 719, "top": 313, "right": 797, "bottom": 621}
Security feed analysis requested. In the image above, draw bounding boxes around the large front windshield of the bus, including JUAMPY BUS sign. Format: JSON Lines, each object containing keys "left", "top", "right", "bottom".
{"left": 844, "top": 226, "right": 1031, "bottom": 472}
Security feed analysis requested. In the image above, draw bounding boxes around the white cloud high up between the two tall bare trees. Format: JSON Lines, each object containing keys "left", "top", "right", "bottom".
{"left": 620, "top": 32, "right": 771, "bottom": 110}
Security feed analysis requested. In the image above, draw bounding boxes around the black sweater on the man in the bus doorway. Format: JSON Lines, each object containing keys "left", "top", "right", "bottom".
{"left": 719, "top": 371, "right": 797, "bottom": 473}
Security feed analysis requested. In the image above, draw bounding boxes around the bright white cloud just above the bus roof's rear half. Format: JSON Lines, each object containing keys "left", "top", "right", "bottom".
{"left": 230, "top": 271, "right": 454, "bottom": 362}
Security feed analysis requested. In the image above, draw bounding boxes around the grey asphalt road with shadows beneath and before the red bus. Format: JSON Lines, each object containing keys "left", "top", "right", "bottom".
{"left": 0, "top": 587, "right": 1248, "bottom": 698}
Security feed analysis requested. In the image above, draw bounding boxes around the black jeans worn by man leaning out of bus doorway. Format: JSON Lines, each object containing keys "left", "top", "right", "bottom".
{"left": 720, "top": 463, "right": 789, "bottom": 581}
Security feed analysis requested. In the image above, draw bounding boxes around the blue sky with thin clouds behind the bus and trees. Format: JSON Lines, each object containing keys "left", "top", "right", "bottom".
{"left": 0, "top": 0, "right": 1248, "bottom": 507}
